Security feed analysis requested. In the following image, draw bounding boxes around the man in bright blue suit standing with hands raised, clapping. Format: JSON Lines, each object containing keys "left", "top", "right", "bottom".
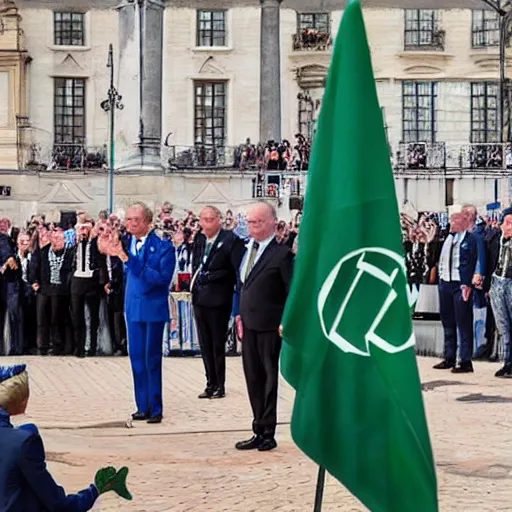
{"left": 106, "top": 203, "right": 176, "bottom": 423}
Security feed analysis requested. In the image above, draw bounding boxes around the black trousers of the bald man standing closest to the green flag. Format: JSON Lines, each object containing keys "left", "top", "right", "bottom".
{"left": 242, "top": 329, "right": 281, "bottom": 438}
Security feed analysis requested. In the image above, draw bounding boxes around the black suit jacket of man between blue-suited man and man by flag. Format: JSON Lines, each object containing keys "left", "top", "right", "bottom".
{"left": 192, "top": 229, "right": 245, "bottom": 308}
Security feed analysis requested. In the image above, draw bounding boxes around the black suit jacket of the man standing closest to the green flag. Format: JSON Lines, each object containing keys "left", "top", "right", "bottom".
{"left": 235, "top": 238, "right": 294, "bottom": 332}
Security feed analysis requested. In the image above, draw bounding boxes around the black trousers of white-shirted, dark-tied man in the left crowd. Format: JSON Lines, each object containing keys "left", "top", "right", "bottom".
{"left": 71, "top": 289, "right": 101, "bottom": 355}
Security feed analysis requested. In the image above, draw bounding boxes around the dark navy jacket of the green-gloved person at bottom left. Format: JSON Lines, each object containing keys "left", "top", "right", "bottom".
{"left": 0, "top": 409, "right": 98, "bottom": 512}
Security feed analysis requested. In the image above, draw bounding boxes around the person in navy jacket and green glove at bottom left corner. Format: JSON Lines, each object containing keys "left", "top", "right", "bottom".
{"left": 0, "top": 365, "right": 132, "bottom": 512}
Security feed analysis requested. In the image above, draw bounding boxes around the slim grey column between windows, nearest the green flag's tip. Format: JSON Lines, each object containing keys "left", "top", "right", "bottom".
{"left": 260, "top": 0, "right": 281, "bottom": 142}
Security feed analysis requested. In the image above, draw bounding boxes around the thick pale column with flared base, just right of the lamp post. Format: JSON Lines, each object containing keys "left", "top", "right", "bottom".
{"left": 119, "top": 0, "right": 165, "bottom": 170}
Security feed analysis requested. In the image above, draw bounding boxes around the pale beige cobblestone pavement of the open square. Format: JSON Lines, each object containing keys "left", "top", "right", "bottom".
{"left": 1, "top": 358, "right": 512, "bottom": 512}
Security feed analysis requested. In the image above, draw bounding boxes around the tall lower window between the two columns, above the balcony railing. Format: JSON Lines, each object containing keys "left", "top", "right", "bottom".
{"left": 194, "top": 82, "right": 227, "bottom": 148}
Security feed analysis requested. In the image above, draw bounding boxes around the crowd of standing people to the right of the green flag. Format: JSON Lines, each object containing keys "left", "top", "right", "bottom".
{"left": 402, "top": 205, "right": 512, "bottom": 377}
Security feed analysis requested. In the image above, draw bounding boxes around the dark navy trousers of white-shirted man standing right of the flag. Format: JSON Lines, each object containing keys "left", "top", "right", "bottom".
{"left": 439, "top": 281, "right": 474, "bottom": 364}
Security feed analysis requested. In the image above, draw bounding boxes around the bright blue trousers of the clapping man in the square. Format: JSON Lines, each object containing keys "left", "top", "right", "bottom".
{"left": 127, "top": 321, "right": 165, "bottom": 417}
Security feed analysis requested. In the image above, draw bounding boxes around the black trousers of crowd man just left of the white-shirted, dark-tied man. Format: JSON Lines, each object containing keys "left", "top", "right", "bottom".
{"left": 37, "top": 293, "right": 69, "bottom": 354}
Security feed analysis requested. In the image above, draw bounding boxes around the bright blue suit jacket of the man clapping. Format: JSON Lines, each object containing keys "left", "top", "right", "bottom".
{"left": 125, "top": 231, "right": 176, "bottom": 322}
